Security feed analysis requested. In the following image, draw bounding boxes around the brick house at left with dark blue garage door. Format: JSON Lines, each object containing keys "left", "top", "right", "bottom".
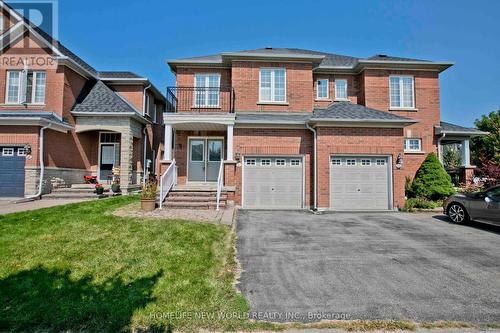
{"left": 0, "top": 2, "right": 165, "bottom": 197}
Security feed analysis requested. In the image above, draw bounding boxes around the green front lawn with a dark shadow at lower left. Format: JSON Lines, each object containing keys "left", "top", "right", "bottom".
{"left": 0, "top": 197, "right": 248, "bottom": 332}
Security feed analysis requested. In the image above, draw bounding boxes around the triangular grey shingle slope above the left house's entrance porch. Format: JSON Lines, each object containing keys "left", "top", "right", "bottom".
{"left": 73, "top": 81, "right": 139, "bottom": 114}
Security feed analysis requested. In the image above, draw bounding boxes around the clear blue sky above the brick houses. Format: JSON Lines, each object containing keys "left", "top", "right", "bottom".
{"left": 53, "top": 0, "right": 500, "bottom": 126}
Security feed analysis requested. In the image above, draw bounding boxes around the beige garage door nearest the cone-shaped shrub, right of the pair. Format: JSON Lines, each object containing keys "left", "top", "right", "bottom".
{"left": 330, "top": 156, "right": 391, "bottom": 210}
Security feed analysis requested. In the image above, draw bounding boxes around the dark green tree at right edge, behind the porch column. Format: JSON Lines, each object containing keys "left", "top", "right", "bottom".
{"left": 471, "top": 109, "right": 500, "bottom": 166}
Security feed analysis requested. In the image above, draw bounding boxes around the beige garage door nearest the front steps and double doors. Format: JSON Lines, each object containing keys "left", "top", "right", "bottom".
{"left": 243, "top": 156, "right": 304, "bottom": 209}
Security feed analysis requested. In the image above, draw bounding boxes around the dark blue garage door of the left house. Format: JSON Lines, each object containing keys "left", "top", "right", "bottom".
{"left": 0, "top": 147, "right": 26, "bottom": 197}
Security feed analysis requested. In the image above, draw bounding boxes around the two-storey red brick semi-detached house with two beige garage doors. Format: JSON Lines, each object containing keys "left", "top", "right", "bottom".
{"left": 162, "top": 48, "right": 480, "bottom": 210}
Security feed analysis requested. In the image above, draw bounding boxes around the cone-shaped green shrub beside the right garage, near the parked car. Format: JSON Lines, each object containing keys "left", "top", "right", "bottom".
{"left": 412, "top": 153, "right": 455, "bottom": 200}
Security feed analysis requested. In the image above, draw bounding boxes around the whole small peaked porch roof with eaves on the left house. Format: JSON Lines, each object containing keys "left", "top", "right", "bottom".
{"left": 71, "top": 80, "right": 145, "bottom": 120}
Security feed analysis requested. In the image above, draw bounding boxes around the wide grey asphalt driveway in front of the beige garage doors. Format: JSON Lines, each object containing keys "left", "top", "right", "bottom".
{"left": 237, "top": 210, "right": 500, "bottom": 323}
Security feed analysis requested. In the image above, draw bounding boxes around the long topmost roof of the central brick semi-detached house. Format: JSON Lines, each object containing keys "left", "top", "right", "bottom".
{"left": 167, "top": 47, "right": 452, "bottom": 71}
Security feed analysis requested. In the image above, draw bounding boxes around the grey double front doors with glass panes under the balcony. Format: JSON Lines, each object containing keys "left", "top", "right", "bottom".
{"left": 188, "top": 138, "right": 223, "bottom": 182}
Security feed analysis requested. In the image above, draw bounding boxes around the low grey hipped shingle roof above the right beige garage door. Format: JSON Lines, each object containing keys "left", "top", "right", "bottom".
{"left": 311, "top": 102, "right": 415, "bottom": 122}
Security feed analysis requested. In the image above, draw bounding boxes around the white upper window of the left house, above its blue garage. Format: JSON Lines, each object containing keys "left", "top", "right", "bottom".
{"left": 5, "top": 71, "right": 46, "bottom": 104}
